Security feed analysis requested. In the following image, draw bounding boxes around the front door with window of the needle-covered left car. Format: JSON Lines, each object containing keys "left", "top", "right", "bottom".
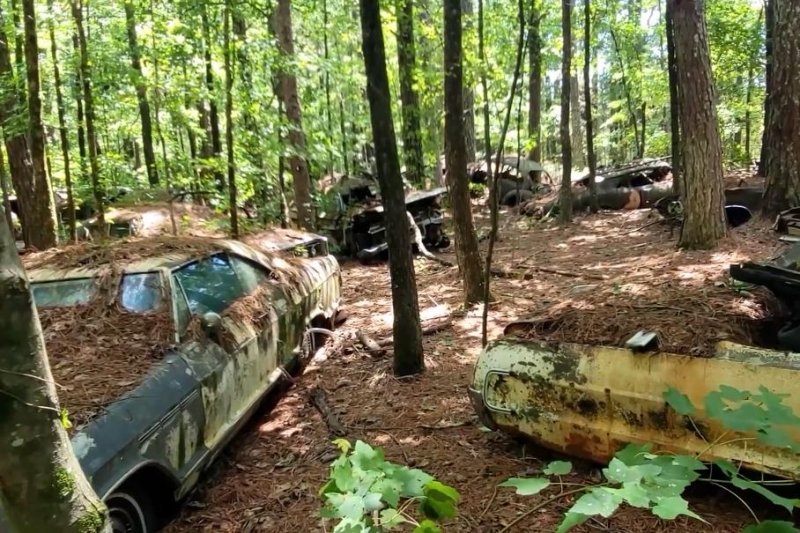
{"left": 172, "top": 253, "right": 261, "bottom": 449}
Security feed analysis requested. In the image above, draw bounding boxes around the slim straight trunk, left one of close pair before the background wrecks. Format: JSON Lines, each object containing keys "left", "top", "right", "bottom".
{"left": 559, "top": 0, "right": 572, "bottom": 225}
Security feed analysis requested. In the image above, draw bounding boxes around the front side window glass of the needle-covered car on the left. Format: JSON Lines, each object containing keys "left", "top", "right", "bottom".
{"left": 175, "top": 254, "right": 245, "bottom": 314}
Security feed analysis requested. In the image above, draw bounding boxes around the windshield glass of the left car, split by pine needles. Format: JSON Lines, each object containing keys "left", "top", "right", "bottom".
{"left": 32, "top": 272, "right": 164, "bottom": 313}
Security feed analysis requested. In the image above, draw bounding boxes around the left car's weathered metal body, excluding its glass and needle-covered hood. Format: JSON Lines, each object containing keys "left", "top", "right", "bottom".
{"left": 30, "top": 231, "right": 341, "bottom": 501}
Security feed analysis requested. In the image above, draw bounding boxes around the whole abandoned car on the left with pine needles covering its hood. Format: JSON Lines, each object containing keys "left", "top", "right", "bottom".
{"left": 26, "top": 231, "right": 341, "bottom": 533}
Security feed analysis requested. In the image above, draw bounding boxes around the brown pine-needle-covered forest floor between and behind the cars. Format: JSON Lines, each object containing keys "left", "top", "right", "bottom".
{"left": 169, "top": 207, "right": 778, "bottom": 533}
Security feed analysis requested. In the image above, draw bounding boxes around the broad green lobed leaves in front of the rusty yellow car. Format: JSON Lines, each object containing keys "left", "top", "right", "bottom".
{"left": 500, "top": 385, "right": 800, "bottom": 533}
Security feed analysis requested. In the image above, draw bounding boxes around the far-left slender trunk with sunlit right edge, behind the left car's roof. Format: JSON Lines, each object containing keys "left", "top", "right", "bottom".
{"left": 22, "top": 0, "right": 58, "bottom": 250}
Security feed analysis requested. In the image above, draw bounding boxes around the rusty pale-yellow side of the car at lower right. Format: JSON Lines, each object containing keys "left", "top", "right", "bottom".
{"left": 471, "top": 339, "right": 800, "bottom": 479}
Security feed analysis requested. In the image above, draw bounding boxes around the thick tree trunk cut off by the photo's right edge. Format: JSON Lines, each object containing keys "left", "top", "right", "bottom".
{"left": 763, "top": 0, "right": 800, "bottom": 215}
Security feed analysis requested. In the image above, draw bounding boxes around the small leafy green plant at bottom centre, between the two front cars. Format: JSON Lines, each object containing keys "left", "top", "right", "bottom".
{"left": 320, "top": 439, "right": 461, "bottom": 533}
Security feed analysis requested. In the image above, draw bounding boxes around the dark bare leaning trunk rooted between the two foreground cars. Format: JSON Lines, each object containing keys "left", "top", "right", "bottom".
{"left": 360, "top": 0, "right": 428, "bottom": 376}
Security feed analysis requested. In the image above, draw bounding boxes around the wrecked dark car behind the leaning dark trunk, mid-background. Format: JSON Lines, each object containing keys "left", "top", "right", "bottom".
{"left": 317, "top": 174, "right": 450, "bottom": 260}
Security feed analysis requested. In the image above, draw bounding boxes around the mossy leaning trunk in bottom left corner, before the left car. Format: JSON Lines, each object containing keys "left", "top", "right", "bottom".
{"left": 0, "top": 211, "right": 110, "bottom": 533}
